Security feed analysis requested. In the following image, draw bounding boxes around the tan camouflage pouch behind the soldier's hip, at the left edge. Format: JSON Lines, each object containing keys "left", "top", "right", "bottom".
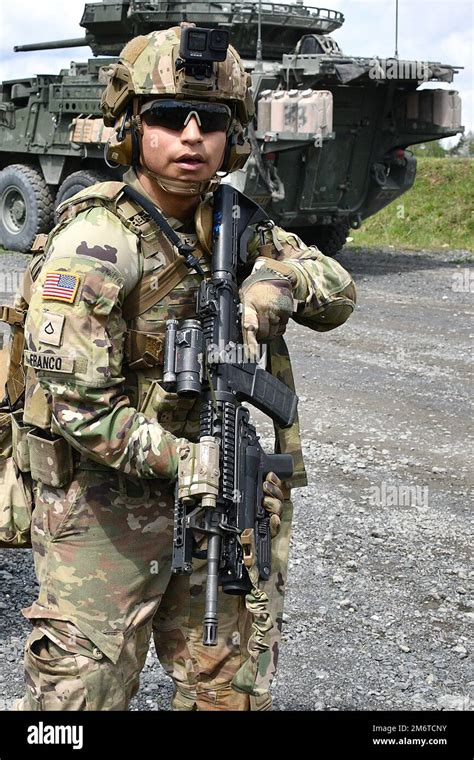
{"left": 0, "top": 409, "right": 33, "bottom": 549}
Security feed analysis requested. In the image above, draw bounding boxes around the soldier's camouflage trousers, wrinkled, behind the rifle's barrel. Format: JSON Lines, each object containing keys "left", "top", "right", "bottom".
{"left": 14, "top": 470, "right": 292, "bottom": 710}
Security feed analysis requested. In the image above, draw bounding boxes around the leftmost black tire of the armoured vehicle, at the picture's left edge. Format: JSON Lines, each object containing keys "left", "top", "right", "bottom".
{"left": 0, "top": 164, "right": 54, "bottom": 252}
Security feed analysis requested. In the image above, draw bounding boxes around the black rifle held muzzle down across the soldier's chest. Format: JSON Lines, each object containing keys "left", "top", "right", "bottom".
{"left": 163, "top": 185, "right": 298, "bottom": 646}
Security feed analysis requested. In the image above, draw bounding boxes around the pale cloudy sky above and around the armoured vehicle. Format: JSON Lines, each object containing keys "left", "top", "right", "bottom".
{"left": 0, "top": 0, "right": 474, "bottom": 141}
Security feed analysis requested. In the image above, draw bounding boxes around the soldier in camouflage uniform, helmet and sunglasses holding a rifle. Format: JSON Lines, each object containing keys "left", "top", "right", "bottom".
{"left": 13, "top": 27, "right": 355, "bottom": 710}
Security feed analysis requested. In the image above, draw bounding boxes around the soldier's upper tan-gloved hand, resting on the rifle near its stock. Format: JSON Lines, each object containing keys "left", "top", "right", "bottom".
{"left": 240, "top": 266, "right": 293, "bottom": 350}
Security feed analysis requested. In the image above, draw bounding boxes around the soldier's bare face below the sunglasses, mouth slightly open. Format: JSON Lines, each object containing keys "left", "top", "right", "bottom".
{"left": 142, "top": 116, "right": 226, "bottom": 180}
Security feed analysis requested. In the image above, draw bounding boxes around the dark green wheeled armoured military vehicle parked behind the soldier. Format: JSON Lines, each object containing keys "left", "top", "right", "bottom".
{"left": 0, "top": 0, "right": 464, "bottom": 255}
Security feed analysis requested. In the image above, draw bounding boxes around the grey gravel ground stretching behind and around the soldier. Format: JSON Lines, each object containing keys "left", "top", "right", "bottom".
{"left": 0, "top": 249, "right": 474, "bottom": 711}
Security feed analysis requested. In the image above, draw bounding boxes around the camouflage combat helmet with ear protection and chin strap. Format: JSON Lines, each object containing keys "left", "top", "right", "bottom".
{"left": 101, "top": 22, "right": 254, "bottom": 195}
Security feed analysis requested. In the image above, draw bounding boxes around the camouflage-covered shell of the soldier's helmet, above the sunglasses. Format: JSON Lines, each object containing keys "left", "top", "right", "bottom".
{"left": 101, "top": 26, "right": 254, "bottom": 127}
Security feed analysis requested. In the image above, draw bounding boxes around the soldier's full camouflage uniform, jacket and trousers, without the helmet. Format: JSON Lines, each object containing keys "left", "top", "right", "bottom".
{"left": 12, "top": 25, "right": 355, "bottom": 710}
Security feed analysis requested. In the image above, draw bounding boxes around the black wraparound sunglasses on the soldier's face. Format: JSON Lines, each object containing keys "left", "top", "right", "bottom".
{"left": 140, "top": 100, "right": 232, "bottom": 133}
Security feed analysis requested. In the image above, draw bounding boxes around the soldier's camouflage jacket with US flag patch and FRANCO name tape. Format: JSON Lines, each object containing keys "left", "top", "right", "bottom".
{"left": 24, "top": 170, "right": 355, "bottom": 486}
